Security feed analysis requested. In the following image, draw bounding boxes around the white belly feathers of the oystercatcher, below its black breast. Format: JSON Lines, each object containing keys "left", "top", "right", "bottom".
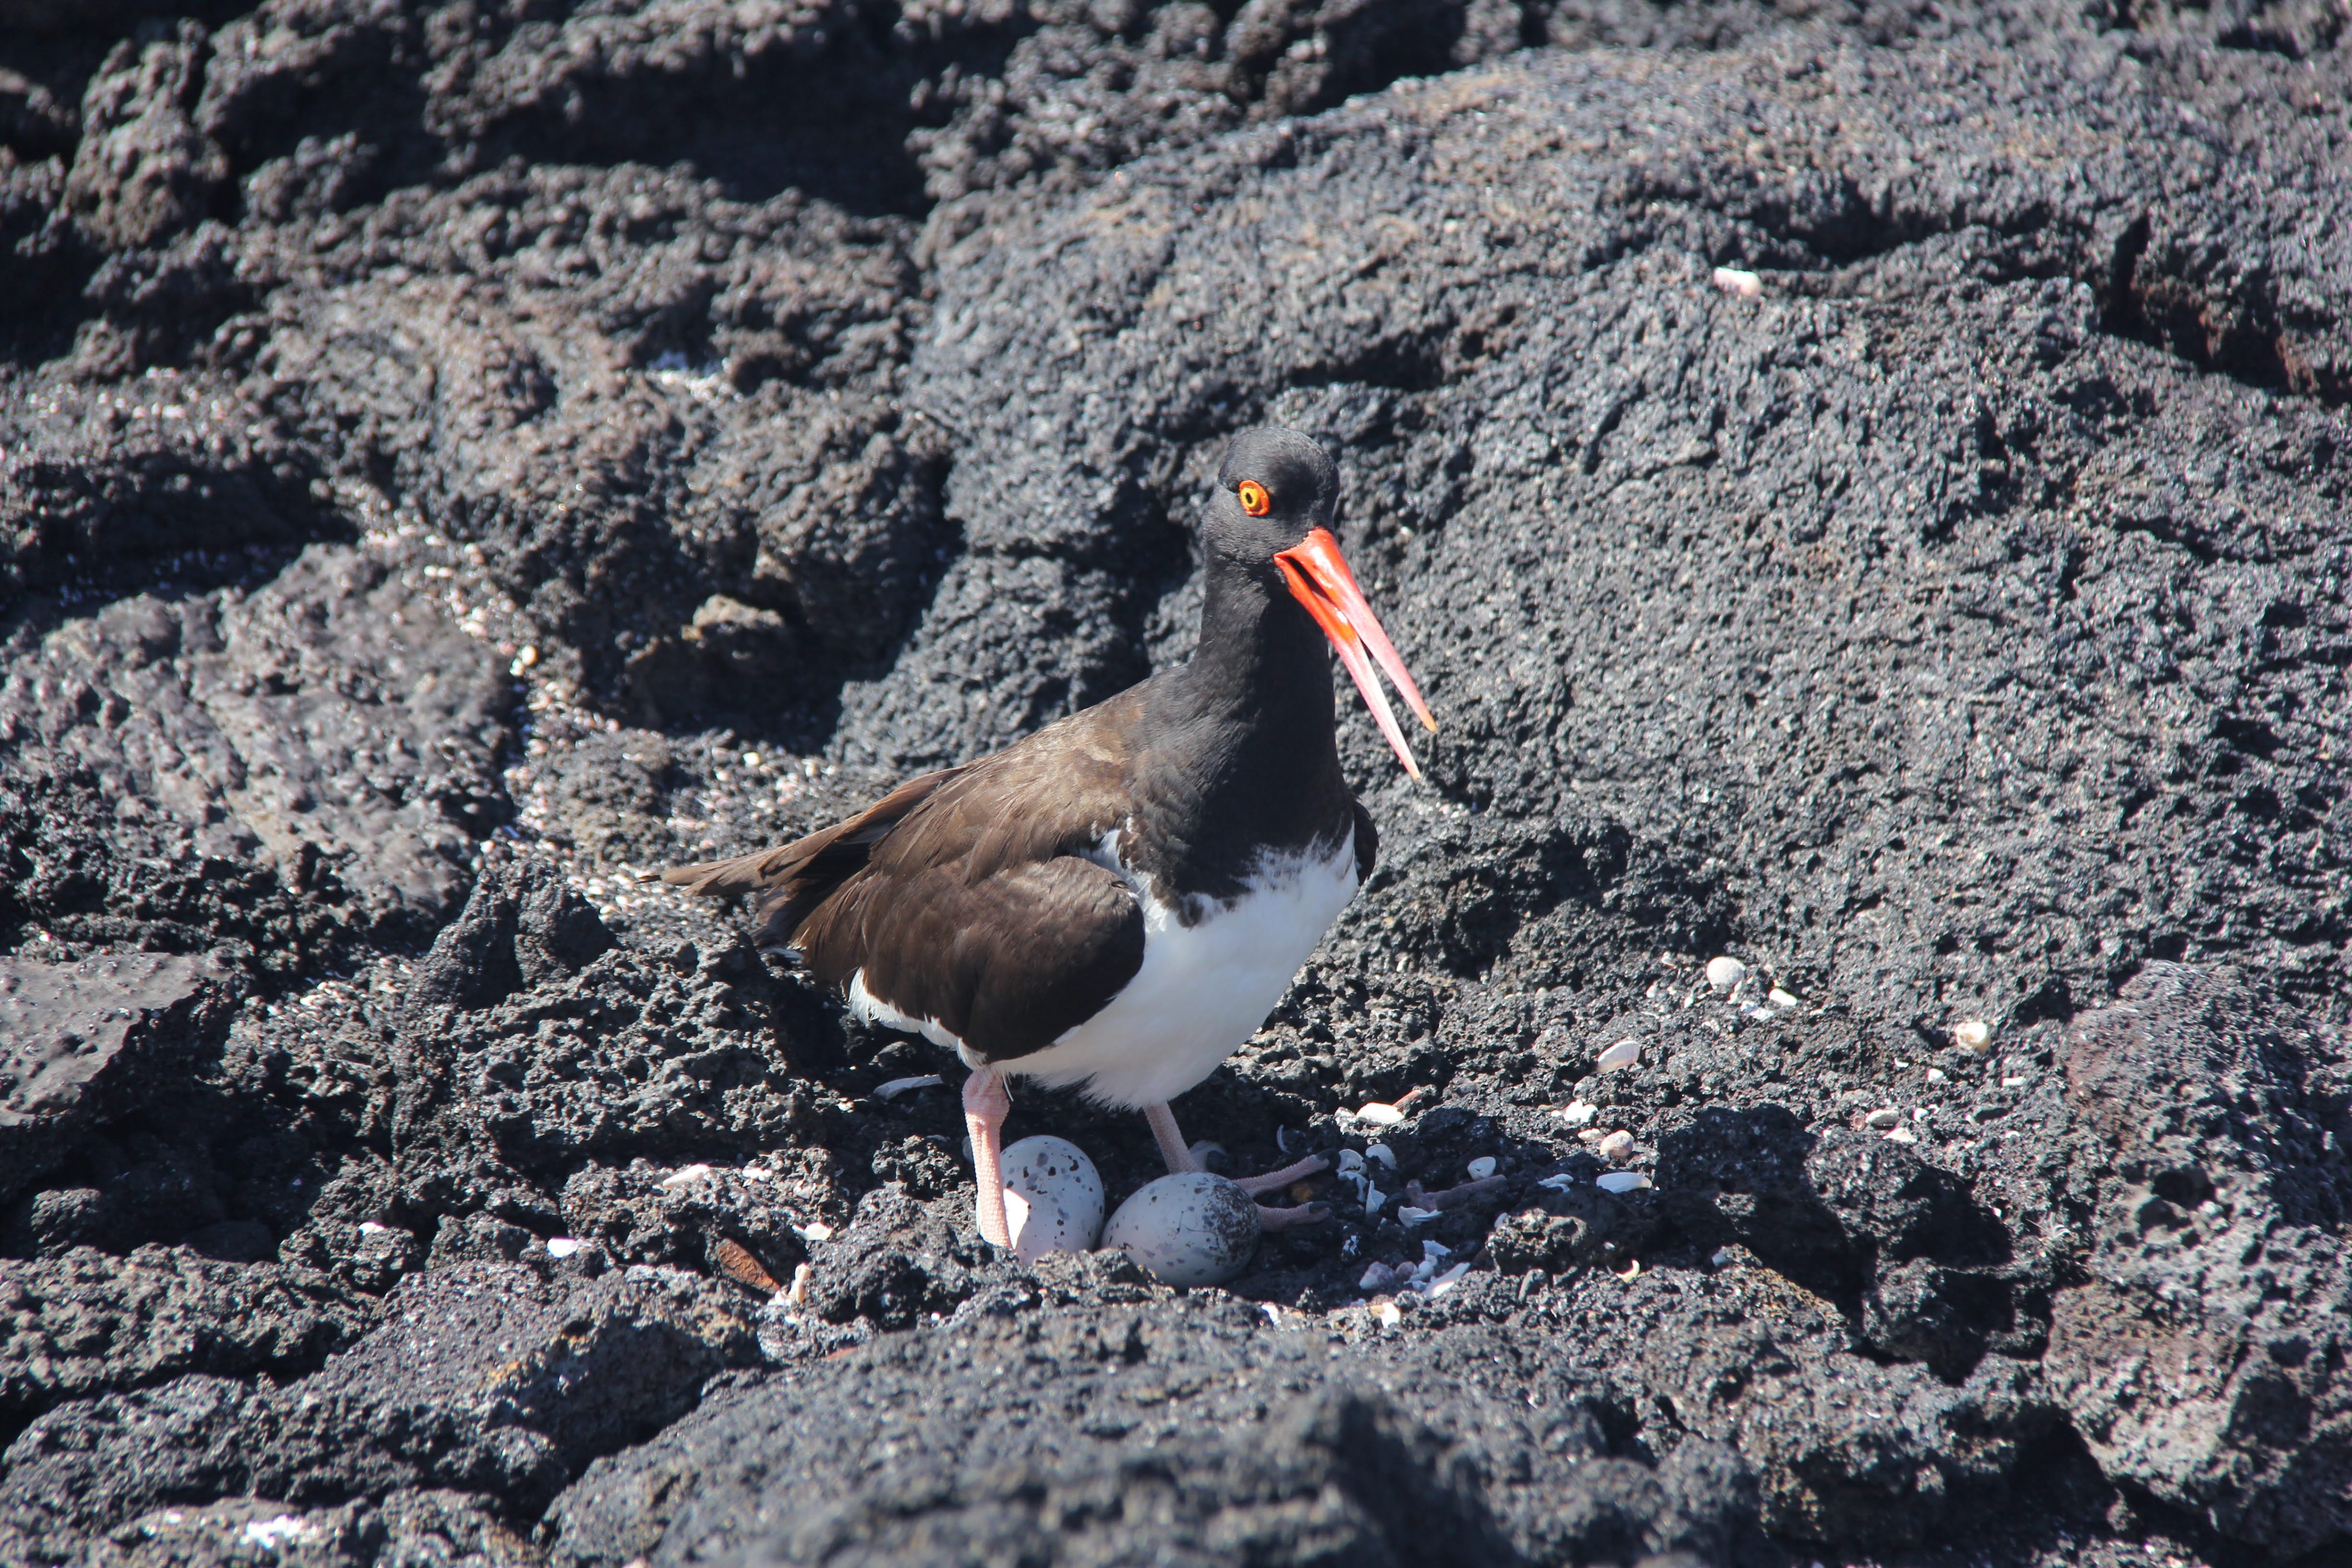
{"left": 1000, "top": 832, "right": 1355, "bottom": 1105}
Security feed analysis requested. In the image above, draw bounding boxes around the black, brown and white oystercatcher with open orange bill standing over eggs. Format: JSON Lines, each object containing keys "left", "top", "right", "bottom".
{"left": 663, "top": 428, "right": 1437, "bottom": 1246}
